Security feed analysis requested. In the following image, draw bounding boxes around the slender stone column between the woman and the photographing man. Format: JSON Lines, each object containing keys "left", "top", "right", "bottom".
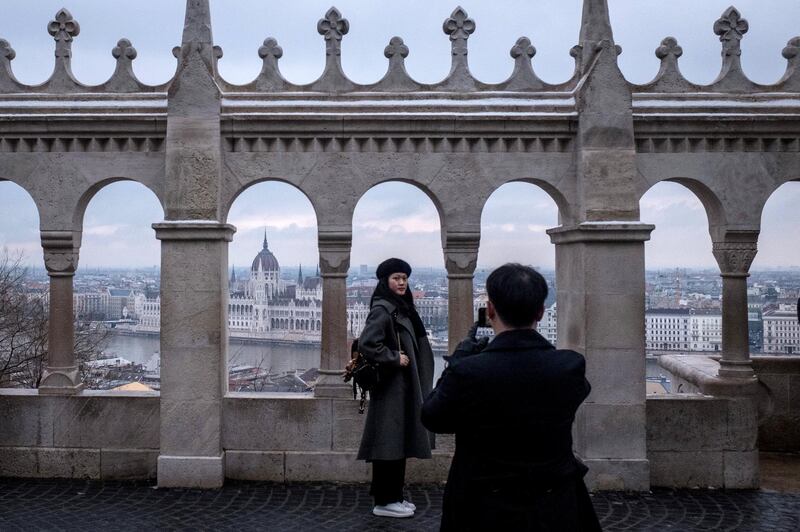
{"left": 444, "top": 232, "right": 481, "bottom": 353}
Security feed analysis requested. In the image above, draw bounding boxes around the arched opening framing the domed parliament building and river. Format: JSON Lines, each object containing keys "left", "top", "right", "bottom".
{"left": 228, "top": 181, "right": 323, "bottom": 393}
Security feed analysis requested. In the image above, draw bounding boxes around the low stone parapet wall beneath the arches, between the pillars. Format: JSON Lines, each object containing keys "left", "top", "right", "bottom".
{"left": 0, "top": 390, "right": 758, "bottom": 488}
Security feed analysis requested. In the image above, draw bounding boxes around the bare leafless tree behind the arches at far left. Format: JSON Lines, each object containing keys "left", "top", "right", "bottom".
{"left": 0, "top": 248, "right": 107, "bottom": 388}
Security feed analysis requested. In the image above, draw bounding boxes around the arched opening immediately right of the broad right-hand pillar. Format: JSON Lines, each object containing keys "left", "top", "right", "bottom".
{"left": 639, "top": 182, "right": 722, "bottom": 393}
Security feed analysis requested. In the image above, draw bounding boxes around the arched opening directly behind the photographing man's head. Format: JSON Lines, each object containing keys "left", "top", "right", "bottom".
{"left": 473, "top": 182, "right": 558, "bottom": 345}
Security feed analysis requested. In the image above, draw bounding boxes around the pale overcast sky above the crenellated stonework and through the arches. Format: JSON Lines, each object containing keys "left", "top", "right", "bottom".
{"left": 0, "top": 0, "right": 800, "bottom": 270}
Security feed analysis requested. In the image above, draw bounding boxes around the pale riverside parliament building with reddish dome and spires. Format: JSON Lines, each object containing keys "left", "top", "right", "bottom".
{"left": 134, "top": 234, "right": 369, "bottom": 344}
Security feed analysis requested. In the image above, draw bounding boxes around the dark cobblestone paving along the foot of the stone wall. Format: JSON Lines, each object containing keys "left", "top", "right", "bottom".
{"left": 0, "top": 479, "right": 800, "bottom": 532}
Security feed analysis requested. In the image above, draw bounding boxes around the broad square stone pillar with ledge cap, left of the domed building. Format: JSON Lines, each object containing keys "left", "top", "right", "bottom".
{"left": 153, "top": 221, "right": 235, "bottom": 488}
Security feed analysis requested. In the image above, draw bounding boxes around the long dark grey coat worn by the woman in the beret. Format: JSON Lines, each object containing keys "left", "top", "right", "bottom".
{"left": 358, "top": 298, "right": 433, "bottom": 460}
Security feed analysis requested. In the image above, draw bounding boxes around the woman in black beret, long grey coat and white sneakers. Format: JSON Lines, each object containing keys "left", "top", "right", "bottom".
{"left": 358, "top": 259, "right": 433, "bottom": 517}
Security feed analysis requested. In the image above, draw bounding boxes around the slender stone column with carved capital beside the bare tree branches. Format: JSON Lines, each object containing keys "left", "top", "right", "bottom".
{"left": 39, "top": 231, "right": 83, "bottom": 395}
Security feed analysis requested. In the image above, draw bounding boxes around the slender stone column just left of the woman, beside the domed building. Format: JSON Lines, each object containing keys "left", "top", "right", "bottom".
{"left": 314, "top": 228, "right": 353, "bottom": 398}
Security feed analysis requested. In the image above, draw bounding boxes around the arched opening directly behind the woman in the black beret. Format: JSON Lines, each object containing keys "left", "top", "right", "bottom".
{"left": 354, "top": 182, "right": 448, "bottom": 376}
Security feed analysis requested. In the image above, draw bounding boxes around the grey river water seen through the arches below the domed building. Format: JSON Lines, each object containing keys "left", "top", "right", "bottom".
{"left": 103, "top": 333, "right": 444, "bottom": 378}
